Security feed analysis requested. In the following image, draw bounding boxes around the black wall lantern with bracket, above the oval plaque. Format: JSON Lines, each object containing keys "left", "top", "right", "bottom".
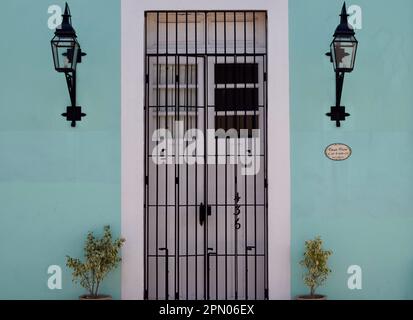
{"left": 326, "top": 2, "right": 358, "bottom": 127}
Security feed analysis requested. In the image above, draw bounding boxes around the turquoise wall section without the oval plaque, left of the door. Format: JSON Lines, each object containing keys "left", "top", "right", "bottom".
{"left": 0, "top": 0, "right": 120, "bottom": 299}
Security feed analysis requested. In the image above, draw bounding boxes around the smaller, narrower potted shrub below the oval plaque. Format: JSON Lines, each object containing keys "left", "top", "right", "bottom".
{"left": 297, "top": 237, "right": 333, "bottom": 300}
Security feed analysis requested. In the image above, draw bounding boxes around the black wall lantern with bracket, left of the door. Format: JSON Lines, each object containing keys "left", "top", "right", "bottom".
{"left": 51, "top": 3, "right": 86, "bottom": 127}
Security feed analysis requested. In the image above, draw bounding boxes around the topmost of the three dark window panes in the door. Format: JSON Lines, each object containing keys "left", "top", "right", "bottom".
{"left": 215, "top": 63, "right": 258, "bottom": 84}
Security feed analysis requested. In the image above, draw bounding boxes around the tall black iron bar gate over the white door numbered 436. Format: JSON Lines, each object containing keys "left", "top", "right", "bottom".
{"left": 144, "top": 11, "right": 268, "bottom": 299}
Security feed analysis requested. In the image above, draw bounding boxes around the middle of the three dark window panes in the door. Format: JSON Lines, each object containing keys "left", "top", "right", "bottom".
{"left": 215, "top": 88, "right": 258, "bottom": 111}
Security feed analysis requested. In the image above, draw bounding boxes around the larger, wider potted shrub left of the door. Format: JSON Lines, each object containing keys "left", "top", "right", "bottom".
{"left": 66, "top": 226, "right": 125, "bottom": 300}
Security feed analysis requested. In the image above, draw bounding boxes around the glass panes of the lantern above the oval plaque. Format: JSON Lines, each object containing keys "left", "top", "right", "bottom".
{"left": 331, "top": 36, "right": 357, "bottom": 72}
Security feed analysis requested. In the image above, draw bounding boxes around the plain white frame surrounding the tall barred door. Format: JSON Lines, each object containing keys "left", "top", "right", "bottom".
{"left": 121, "top": 0, "right": 290, "bottom": 299}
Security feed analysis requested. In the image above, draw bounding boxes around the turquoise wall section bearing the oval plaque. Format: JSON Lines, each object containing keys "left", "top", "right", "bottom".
{"left": 289, "top": 0, "right": 413, "bottom": 299}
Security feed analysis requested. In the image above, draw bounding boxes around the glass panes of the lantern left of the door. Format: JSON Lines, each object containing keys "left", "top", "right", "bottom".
{"left": 52, "top": 38, "right": 79, "bottom": 72}
